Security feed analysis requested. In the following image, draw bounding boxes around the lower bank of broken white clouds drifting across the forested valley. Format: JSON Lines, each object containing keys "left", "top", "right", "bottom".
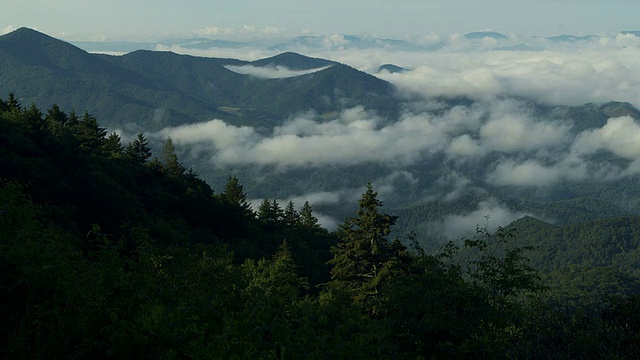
{"left": 158, "top": 99, "right": 640, "bottom": 186}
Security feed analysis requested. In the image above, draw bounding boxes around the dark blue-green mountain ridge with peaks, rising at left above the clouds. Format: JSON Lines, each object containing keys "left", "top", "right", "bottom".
{"left": 0, "top": 28, "right": 397, "bottom": 131}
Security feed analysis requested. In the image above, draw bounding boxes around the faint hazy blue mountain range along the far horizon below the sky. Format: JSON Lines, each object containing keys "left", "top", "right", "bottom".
{"left": 58, "top": 31, "right": 640, "bottom": 54}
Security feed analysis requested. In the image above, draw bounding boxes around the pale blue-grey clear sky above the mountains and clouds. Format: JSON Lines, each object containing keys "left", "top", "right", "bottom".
{"left": 0, "top": 0, "right": 640, "bottom": 40}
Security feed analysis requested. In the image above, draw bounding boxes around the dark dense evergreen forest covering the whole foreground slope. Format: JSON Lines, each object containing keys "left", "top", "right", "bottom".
{"left": 0, "top": 94, "right": 640, "bottom": 359}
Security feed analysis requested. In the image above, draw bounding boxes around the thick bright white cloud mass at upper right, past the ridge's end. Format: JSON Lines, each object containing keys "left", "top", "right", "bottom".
{"left": 372, "top": 40, "right": 640, "bottom": 106}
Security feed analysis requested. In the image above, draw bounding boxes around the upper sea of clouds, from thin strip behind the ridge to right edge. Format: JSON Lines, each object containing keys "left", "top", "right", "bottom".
{"left": 135, "top": 30, "right": 640, "bottom": 107}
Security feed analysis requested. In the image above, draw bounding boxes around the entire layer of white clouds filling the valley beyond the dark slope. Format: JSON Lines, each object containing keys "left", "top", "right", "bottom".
{"left": 120, "top": 33, "right": 640, "bottom": 237}
